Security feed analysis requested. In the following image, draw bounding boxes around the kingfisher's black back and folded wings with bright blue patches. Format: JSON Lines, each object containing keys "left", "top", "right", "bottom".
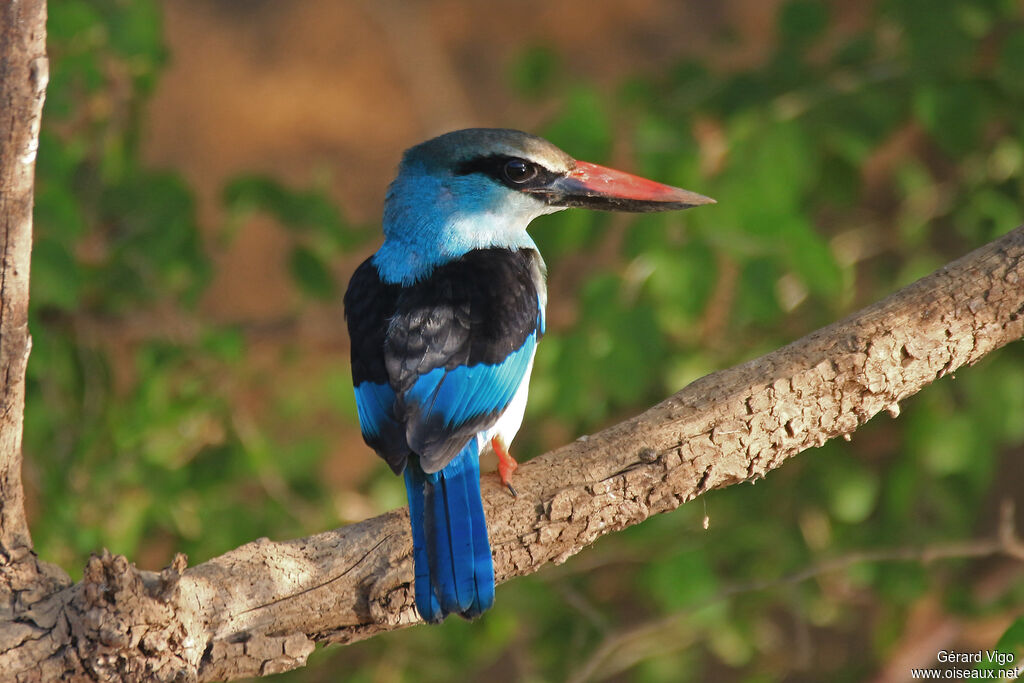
{"left": 345, "top": 249, "right": 544, "bottom": 472}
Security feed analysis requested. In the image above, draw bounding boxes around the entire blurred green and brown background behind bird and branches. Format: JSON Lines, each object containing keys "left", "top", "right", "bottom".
{"left": 25, "top": 0, "right": 1024, "bottom": 682}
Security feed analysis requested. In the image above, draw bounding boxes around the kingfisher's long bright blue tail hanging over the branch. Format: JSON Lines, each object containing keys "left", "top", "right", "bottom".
{"left": 406, "top": 438, "right": 495, "bottom": 623}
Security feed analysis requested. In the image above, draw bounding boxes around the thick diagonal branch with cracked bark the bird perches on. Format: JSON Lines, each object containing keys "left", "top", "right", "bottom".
{"left": 0, "top": 227, "right": 1024, "bottom": 681}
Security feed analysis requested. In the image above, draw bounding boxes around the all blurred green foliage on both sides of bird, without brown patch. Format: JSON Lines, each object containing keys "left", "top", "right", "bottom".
{"left": 26, "top": 0, "right": 1024, "bottom": 681}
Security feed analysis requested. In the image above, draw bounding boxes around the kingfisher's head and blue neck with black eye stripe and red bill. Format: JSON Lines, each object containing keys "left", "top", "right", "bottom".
{"left": 376, "top": 128, "right": 715, "bottom": 283}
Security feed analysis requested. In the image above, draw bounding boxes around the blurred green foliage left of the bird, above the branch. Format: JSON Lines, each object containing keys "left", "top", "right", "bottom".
{"left": 26, "top": 0, "right": 372, "bottom": 574}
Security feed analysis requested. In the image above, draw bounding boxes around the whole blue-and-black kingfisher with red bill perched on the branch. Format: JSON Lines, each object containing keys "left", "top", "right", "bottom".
{"left": 344, "top": 128, "right": 714, "bottom": 623}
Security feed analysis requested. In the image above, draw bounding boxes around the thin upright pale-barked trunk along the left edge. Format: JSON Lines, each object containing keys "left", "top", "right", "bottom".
{"left": 0, "top": 0, "right": 71, "bottom": 676}
